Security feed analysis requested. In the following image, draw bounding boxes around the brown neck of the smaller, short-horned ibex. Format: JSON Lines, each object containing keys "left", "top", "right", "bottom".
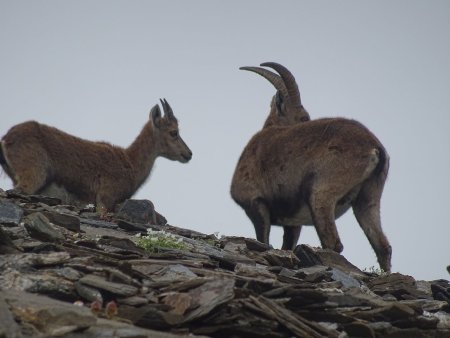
{"left": 125, "top": 123, "right": 158, "bottom": 188}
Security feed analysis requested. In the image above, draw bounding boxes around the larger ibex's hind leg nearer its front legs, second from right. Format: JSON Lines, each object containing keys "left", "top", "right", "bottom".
{"left": 309, "top": 192, "right": 344, "bottom": 253}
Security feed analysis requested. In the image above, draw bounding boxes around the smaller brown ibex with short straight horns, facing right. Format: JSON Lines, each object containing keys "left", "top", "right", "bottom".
{"left": 0, "top": 99, "right": 192, "bottom": 212}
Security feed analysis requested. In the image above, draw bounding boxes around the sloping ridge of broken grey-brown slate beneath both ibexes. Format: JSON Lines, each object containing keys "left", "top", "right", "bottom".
{"left": 0, "top": 190, "right": 450, "bottom": 338}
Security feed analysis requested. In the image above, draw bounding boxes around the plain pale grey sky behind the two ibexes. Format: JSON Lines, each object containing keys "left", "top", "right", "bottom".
{"left": 0, "top": 0, "right": 450, "bottom": 280}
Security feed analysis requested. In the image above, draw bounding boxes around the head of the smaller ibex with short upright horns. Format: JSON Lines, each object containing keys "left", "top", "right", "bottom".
{"left": 150, "top": 99, "right": 192, "bottom": 163}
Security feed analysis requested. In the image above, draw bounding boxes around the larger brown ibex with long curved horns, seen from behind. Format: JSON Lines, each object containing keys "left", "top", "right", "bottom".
{"left": 231, "top": 63, "right": 391, "bottom": 271}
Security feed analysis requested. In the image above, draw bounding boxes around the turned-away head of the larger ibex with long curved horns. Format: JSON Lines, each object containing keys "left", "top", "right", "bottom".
{"left": 240, "top": 62, "right": 310, "bottom": 127}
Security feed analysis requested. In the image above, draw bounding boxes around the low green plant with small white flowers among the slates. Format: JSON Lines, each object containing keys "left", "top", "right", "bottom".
{"left": 136, "top": 229, "right": 187, "bottom": 253}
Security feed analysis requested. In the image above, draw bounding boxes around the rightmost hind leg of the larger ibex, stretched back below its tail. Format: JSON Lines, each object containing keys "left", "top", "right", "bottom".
{"left": 353, "top": 180, "right": 392, "bottom": 272}
